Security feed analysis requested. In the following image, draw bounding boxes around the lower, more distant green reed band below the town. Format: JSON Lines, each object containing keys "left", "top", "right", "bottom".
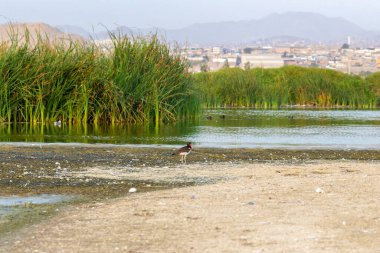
{"left": 194, "top": 66, "right": 380, "bottom": 109}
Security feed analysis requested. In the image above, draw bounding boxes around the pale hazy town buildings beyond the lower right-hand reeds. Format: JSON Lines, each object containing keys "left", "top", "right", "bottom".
{"left": 183, "top": 42, "right": 380, "bottom": 74}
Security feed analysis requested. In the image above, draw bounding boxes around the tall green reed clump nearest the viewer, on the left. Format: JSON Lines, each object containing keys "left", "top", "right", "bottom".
{"left": 0, "top": 27, "right": 199, "bottom": 125}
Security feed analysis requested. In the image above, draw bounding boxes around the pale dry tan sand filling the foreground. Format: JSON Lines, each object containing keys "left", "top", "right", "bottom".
{"left": 0, "top": 161, "right": 380, "bottom": 253}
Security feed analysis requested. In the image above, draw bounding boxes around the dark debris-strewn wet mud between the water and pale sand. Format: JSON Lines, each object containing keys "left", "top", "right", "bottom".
{"left": 0, "top": 145, "right": 380, "bottom": 236}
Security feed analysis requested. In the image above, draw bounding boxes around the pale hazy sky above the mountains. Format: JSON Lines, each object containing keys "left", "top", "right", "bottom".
{"left": 0, "top": 0, "right": 380, "bottom": 30}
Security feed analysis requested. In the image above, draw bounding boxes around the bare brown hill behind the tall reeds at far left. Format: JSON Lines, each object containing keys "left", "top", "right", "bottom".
{"left": 0, "top": 23, "right": 85, "bottom": 44}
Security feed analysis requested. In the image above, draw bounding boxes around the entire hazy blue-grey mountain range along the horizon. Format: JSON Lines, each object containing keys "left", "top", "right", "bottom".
{"left": 0, "top": 12, "right": 380, "bottom": 46}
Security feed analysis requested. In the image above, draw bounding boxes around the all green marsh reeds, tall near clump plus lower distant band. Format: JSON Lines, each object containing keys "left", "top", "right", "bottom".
{"left": 0, "top": 31, "right": 380, "bottom": 126}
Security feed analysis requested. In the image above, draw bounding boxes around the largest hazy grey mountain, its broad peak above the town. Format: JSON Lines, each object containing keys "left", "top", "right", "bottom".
{"left": 166, "top": 12, "right": 376, "bottom": 44}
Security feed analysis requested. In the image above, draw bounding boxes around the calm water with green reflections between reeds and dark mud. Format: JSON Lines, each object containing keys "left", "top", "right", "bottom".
{"left": 0, "top": 109, "right": 380, "bottom": 149}
